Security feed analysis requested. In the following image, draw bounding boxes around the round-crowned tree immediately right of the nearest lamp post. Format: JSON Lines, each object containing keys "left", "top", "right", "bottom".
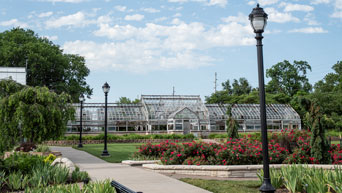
{"left": 266, "top": 60, "right": 312, "bottom": 96}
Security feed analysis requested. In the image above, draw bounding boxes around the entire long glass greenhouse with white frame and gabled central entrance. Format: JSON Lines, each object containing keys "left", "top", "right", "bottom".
{"left": 68, "top": 95, "right": 301, "bottom": 134}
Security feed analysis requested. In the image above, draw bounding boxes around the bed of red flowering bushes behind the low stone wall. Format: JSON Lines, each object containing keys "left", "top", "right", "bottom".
{"left": 134, "top": 130, "right": 342, "bottom": 165}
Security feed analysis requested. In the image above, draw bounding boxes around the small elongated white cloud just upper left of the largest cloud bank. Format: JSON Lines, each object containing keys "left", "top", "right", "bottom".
{"left": 45, "top": 11, "right": 94, "bottom": 28}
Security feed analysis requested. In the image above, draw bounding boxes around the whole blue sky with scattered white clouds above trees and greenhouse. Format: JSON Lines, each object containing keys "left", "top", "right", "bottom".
{"left": 0, "top": 0, "right": 342, "bottom": 102}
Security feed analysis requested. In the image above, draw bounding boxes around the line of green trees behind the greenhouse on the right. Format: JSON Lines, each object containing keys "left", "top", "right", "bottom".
{"left": 205, "top": 60, "right": 342, "bottom": 129}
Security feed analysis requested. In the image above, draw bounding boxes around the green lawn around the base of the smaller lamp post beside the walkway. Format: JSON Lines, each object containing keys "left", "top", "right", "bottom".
{"left": 73, "top": 143, "right": 143, "bottom": 163}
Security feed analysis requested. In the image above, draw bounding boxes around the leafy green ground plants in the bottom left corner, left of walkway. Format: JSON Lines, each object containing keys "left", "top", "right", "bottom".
{"left": 0, "top": 153, "right": 89, "bottom": 192}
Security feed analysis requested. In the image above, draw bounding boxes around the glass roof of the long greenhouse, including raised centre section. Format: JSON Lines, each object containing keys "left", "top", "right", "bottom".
{"left": 73, "top": 95, "right": 300, "bottom": 122}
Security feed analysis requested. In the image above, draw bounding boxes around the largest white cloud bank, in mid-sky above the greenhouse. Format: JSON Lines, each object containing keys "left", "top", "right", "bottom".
{"left": 73, "top": 19, "right": 255, "bottom": 73}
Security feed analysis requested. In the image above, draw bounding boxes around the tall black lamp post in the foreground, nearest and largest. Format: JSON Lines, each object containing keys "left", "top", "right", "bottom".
{"left": 249, "top": 4, "right": 275, "bottom": 193}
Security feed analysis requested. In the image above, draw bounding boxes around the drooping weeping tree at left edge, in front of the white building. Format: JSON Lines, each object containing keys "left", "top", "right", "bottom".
{"left": 0, "top": 87, "right": 74, "bottom": 151}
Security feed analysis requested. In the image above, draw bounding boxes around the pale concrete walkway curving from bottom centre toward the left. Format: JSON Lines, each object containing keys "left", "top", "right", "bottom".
{"left": 50, "top": 147, "right": 209, "bottom": 193}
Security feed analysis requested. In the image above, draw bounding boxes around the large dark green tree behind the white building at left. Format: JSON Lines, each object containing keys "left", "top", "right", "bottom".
{"left": 0, "top": 28, "right": 92, "bottom": 102}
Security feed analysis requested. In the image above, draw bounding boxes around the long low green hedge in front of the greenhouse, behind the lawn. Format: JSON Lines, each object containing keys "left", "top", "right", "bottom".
{"left": 60, "top": 133, "right": 195, "bottom": 140}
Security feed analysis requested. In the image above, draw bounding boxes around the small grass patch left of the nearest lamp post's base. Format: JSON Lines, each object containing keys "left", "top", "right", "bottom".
{"left": 181, "top": 178, "right": 261, "bottom": 193}
